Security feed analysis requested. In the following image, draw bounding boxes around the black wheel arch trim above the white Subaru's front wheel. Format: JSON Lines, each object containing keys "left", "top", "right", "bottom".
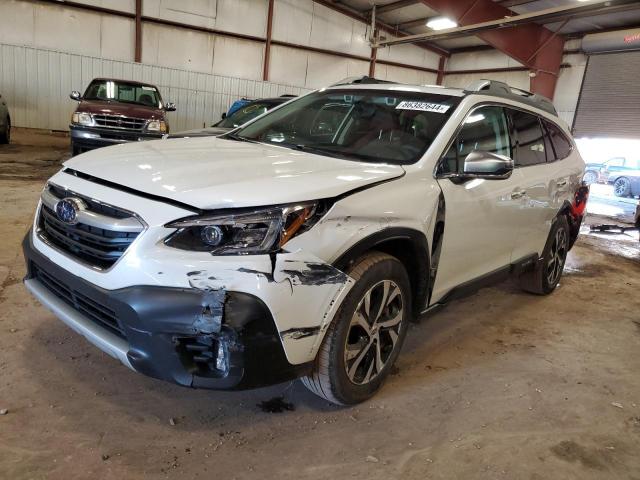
{"left": 332, "top": 227, "right": 430, "bottom": 316}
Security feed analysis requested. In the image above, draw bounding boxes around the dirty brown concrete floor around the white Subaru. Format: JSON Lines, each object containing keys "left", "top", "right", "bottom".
{"left": 0, "top": 133, "right": 640, "bottom": 480}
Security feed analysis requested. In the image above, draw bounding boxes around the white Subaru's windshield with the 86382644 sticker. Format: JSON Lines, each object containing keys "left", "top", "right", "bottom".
{"left": 234, "top": 89, "right": 460, "bottom": 164}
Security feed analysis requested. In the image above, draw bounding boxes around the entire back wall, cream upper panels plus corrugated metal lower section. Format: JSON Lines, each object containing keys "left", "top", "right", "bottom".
{"left": 0, "top": 0, "right": 440, "bottom": 131}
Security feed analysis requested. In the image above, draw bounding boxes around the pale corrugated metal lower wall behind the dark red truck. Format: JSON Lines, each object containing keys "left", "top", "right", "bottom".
{"left": 0, "top": 40, "right": 309, "bottom": 132}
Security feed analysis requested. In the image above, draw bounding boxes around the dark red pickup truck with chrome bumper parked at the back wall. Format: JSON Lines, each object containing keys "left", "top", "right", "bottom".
{"left": 69, "top": 78, "right": 176, "bottom": 155}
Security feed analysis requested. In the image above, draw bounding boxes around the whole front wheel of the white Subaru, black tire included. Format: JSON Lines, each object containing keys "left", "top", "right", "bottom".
{"left": 301, "top": 252, "right": 411, "bottom": 405}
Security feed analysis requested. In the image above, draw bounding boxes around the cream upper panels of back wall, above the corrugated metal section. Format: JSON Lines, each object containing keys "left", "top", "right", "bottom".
{"left": 0, "top": 0, "right": 440, "bottom": 88}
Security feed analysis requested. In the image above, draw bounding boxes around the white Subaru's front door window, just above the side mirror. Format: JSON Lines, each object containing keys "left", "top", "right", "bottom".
{"left": 438, "top": 106, "right": 511, "bottom": 174}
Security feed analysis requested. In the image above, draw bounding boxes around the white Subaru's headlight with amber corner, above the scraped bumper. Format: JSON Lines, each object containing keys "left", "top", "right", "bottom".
{"left": 165, "top": 202, "right": 321, "bottom": 255}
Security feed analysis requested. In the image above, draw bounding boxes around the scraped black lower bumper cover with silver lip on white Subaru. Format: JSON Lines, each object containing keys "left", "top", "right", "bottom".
{"left": 23, "top": 233, "right": 311, "bottom": 389}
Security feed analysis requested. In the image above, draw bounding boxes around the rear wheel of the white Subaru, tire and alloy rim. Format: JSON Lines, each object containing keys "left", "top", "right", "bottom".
{"left": 518, "top": 215, "right": 571, "bottom": 295}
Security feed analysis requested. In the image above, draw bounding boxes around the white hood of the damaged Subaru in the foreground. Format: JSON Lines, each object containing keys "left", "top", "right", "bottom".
{"left": 64, "top": 137, "right": 404, "bottom": 209}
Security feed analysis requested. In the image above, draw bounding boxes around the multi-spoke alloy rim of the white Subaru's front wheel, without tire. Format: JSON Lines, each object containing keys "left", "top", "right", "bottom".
{"left": 344, "top": 280, "right": 404, "bottom": 385}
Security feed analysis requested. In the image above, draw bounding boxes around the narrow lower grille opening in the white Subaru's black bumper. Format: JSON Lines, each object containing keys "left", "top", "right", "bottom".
{"left": 32, "top": 264, "right": 126, "bottom": 338}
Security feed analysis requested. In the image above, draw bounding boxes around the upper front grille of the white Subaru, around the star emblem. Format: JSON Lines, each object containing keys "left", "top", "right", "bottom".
{"left": 38, "top": 184, "right": 143, "bottom": 270}
